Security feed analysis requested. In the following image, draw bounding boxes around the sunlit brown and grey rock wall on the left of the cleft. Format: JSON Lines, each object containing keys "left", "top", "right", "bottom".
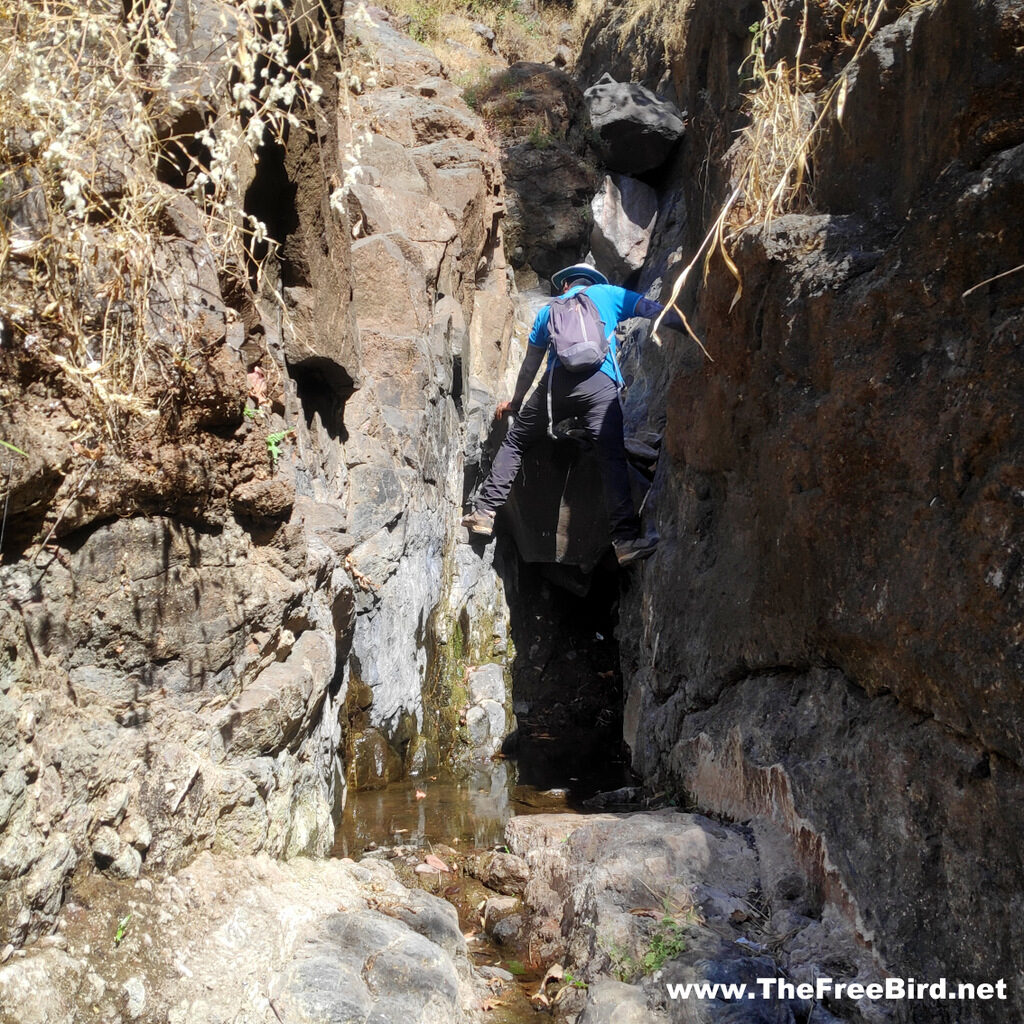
{"left": 0, "top": 0, "right": 515, "bottom": 948}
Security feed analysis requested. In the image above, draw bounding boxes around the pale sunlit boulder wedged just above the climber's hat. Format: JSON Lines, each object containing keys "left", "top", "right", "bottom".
{"left": 590, "top": 174, "right": 657, "bottom": 282}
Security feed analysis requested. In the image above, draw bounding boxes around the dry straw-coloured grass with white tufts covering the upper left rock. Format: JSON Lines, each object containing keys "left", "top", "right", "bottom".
{"left": 0, "top": 0, "right": 336, "bottom": 437}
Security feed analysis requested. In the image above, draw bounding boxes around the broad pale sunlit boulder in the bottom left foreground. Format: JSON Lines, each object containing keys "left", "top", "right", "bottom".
{"left": 0, "top": 854, "right": 483, "bottom": 1024}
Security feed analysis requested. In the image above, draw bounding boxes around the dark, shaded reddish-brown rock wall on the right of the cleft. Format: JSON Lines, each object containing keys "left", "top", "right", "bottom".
{"left": 583, "top": 0, "right": 1024, "bottom": 1022}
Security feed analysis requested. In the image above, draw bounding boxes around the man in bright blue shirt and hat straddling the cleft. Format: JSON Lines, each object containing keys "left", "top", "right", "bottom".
{"left": 462, "top": 263, "right": 682, "bottom": 565}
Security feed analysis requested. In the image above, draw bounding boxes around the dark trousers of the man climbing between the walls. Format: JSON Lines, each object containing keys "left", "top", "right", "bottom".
{"left": 476, "top": 367, "right": 640, "bottom": 541}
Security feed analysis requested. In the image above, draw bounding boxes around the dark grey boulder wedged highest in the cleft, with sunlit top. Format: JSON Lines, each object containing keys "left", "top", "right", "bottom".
{"left": 584, "top": 74, "right": 684, "bottom": 174}
